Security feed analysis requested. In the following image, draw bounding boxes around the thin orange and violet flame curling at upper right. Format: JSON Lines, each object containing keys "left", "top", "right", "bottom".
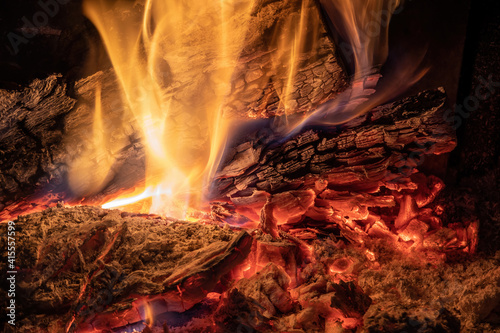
{"left": 287, "top": 0, "right": 429, "bottom": 130}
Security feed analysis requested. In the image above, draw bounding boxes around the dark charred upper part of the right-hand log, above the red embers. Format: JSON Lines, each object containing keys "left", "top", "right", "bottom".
{"left": 212, "top": 89, "right": 456, "bottom": 200}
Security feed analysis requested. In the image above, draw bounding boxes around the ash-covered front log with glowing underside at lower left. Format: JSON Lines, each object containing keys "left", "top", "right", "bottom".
{"left": 1, "top": 206, "right": 252, "bottom": 332}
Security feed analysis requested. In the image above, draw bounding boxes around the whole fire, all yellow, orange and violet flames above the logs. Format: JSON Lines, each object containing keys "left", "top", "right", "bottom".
{"left": 69, "top": 0, "right": 425, "bottom": 219}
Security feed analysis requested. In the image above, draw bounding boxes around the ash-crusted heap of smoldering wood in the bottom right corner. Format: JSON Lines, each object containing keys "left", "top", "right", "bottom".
{"left": 214, "top": 231, "right": 500, "bottom": 332}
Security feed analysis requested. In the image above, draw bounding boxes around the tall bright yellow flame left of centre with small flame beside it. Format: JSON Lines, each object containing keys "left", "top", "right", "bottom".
{"left": 80, "top": 0, "right": 253, "bottom": 218}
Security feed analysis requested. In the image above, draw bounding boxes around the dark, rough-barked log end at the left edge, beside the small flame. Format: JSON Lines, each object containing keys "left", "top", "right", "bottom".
{"left": 0, "top": 75, "right": 76, "bottom": 211}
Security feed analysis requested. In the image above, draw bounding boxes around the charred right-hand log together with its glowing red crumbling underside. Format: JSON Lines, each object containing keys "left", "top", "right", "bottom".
{"left": 208, "top": 89, "right": 464, "bottom": 249}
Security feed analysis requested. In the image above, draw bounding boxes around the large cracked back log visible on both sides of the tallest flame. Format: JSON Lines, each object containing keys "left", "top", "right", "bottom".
{"left": 0, "top": 0, "right": 347, "bottom": 219}
